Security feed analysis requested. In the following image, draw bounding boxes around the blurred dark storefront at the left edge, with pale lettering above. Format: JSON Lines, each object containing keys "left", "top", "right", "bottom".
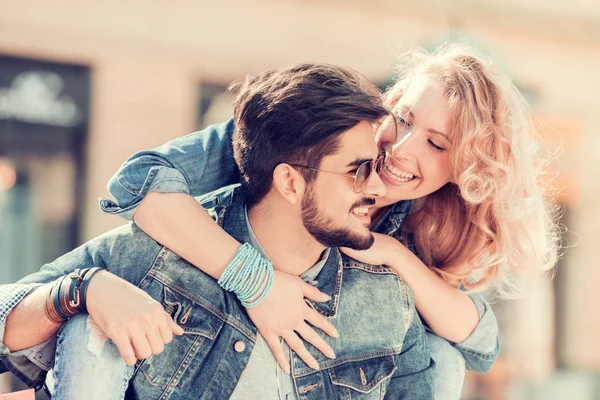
{"left": 0, "top": 56, "right": 90, "bottom": 396}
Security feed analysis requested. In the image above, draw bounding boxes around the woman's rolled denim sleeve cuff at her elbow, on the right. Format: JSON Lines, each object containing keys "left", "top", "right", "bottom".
{"left": 454, "top": 294, "right": 500, "bottom": 374}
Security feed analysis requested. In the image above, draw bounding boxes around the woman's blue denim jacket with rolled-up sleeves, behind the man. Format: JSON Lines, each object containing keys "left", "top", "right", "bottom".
{"left": 100, "top": 119, "right": 499, "bottom": 374}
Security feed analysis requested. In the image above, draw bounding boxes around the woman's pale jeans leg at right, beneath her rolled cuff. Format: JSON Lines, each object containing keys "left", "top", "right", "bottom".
{"left": 427, "top": 331, "right": 465, "bottom": 400}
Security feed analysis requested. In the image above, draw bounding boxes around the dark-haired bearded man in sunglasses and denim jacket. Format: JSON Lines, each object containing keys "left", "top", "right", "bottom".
{"left": 0, "top": 64, "right": 433, "bottom": 400}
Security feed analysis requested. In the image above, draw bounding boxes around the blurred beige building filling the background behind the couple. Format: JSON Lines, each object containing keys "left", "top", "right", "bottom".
{"left": 0, "top": 0, "right": 600, "bottom": 399}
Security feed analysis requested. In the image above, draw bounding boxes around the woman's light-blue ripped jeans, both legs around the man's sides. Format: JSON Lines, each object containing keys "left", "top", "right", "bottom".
{"left": 49, "top": 314, "right": 465, "bottom": 400}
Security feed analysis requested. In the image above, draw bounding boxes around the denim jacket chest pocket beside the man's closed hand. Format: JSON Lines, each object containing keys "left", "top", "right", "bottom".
{"left": 140, "top": 281, "right": 223, "bottom": 388}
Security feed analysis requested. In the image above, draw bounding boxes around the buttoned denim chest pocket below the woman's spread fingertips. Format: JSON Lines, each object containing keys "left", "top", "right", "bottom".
{"left": 328, "top": 356, "right": 397, "bottom": 400}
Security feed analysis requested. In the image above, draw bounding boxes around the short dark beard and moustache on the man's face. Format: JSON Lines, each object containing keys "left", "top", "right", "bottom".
{"left": 302, "top": 188, "right": 375, "bottom": 250}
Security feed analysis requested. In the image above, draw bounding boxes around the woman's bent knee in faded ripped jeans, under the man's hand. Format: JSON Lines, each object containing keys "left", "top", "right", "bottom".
{"left": 52, "top": 314, "right": 134, "bottom": 400}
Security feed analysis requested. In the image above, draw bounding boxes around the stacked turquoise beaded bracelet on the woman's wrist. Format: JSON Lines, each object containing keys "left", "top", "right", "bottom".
{"left": 218, "top": 243, "right": 275, "bottom": 308}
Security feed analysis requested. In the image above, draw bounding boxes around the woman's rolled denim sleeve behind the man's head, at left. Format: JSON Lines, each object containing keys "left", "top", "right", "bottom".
{"left": 100, "top": 119, "right": 240, "bottom": 220}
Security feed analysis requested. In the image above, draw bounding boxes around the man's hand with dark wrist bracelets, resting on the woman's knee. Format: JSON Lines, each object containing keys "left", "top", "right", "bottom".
{"left": 87, "top": 271, "right": 183, "bottom": 365}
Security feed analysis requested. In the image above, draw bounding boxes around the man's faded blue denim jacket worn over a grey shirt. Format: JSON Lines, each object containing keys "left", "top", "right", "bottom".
{"left": 0, "top": 186, "right": 435, "bottom": 400}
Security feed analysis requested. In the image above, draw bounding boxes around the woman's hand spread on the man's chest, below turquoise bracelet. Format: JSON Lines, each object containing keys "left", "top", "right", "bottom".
{"left": 247, "top": 271, "right": 339, "bottom": 373}
